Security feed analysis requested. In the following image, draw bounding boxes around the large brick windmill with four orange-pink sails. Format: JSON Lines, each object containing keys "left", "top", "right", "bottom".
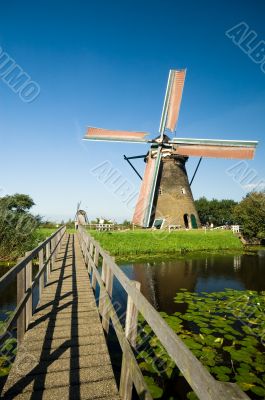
{"left": 84, "top": 69, "right": 258, "bottom": 228}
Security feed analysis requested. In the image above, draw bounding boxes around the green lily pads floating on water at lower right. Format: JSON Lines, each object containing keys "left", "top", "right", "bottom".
{"left": 137, "top": 289, "right": 265, "bottom": 399}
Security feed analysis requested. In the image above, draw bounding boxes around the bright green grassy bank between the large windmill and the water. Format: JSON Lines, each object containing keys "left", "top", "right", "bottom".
{"left": 87, "top": 230, "right": 243, "bottom": 259}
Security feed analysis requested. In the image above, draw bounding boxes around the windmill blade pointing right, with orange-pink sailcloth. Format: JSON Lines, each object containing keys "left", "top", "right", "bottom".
{"left": 168, "top": 138, "right": 258, "bottom": 160}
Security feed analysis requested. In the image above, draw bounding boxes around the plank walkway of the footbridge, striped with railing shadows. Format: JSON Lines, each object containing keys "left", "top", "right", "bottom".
{"left": 3, "top": 235, "right": 119, "bottom": 400}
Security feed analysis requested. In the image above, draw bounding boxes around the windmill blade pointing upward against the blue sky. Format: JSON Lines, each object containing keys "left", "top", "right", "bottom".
{"left": 159, "top": 69, "right": 186, "bottom": 137}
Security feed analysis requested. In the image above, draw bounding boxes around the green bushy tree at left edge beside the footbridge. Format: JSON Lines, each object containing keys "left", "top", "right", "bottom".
{"left": 0, "top": 194, "right": 40, "bottom": 261}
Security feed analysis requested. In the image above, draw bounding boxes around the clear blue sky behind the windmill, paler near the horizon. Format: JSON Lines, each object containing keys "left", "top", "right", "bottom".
{"left": 0, "top": 0, "right": 265, "bottom": 220}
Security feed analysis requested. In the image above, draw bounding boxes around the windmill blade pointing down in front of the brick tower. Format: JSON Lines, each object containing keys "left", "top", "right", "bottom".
{"left": 133, "top": 147, "right": 161, "bottom": 228}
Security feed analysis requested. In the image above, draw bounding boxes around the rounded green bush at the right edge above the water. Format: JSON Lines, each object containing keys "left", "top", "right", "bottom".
{"left": 234, "top": 191, "right": 265, "bottom": 241}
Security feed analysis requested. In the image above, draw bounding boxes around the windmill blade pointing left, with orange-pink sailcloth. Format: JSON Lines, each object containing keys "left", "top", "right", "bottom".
{"left": 84, "top": 127, "right": 148, "bottom": 143}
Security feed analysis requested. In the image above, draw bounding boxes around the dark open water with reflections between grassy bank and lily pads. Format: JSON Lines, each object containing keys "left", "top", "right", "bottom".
{"left": 119, "top": 250, "right": 265, "bottom": 313}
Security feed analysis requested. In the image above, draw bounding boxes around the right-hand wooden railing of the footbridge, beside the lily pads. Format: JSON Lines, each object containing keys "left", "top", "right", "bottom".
{"left": 78, "top": 226, "right": 249, "bottom": 400}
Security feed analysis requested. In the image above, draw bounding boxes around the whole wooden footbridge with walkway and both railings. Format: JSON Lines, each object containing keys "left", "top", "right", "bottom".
{"left": 0, "top": 227, "right": 249, "bottom": 400}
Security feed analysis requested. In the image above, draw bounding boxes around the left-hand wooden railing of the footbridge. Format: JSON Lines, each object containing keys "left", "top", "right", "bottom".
{"left": 0, "top": 226, "right": 66, "bottom": 345}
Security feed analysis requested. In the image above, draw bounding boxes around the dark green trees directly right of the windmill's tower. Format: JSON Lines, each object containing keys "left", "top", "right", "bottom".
{"left": 195, "top": 197, "right": 237, "bottom": 226}
